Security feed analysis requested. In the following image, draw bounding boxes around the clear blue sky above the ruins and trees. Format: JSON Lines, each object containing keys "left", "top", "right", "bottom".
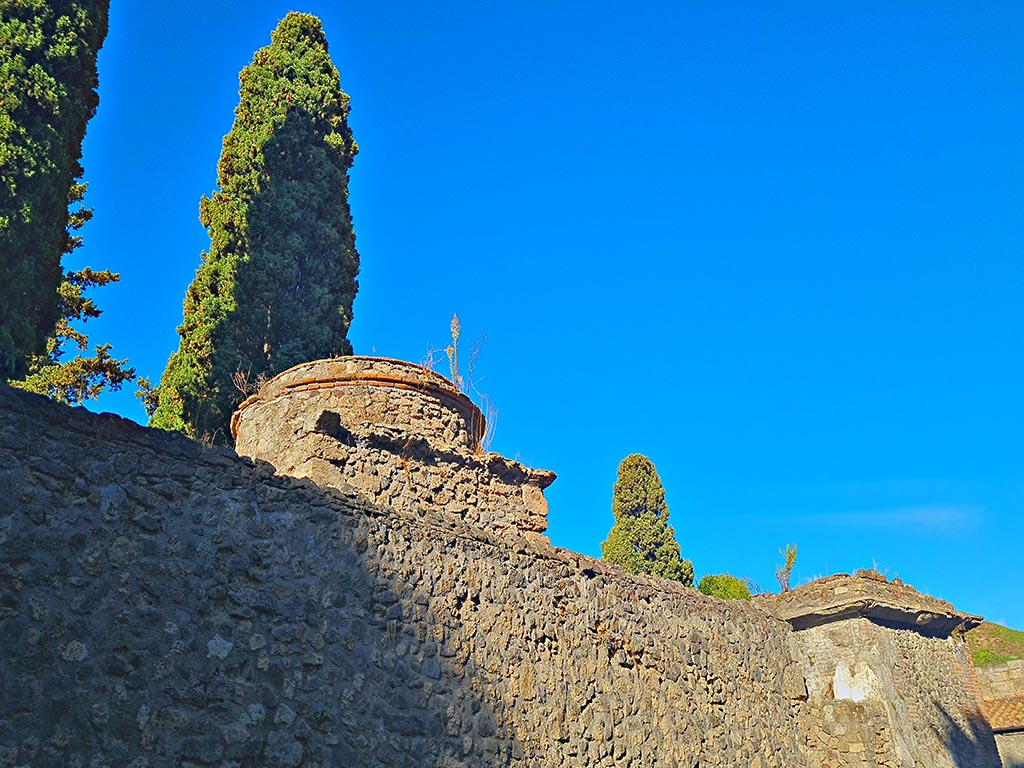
{"left": 76, "top": 0, "right": 1024, "bottom": 629}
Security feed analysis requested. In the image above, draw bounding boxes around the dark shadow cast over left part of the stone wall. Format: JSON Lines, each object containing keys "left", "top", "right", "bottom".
{"left": 0, "top": 391, "right": 512, "bottom": 768}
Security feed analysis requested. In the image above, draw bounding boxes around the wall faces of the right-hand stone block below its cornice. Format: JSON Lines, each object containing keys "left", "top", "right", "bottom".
{"left": 794, "top": 617, "right": 998, "bottom": 768}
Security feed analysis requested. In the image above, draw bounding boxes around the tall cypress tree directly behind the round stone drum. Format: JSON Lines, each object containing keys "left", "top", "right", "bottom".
{"left": 144, "top": 12, "right": 359, "bottom": 442}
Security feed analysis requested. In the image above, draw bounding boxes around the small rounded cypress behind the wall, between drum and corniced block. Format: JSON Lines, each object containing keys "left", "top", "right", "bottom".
{"left": 601, "top": 454, "right": 693, "bottom": 587}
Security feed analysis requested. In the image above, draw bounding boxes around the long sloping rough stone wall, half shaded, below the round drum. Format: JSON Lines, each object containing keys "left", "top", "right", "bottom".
{"left": 0, "top": 388, "right": 815, "bottom": 768}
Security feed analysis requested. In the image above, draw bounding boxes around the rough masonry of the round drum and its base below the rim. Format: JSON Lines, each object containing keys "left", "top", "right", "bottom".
{"left": 236, "top": 372, "right": 554, "bottom": 536}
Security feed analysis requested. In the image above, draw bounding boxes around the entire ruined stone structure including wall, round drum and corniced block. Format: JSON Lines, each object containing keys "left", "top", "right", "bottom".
{"left": 0, "top": 358, "right": 997, "bottom": 768}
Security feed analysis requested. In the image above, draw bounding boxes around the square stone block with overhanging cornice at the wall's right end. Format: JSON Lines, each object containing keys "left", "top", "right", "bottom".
{"left": 757, "top": 571, "right": 998, "bottom": 768}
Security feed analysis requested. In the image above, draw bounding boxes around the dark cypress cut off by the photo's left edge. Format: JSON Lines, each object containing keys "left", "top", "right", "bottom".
{"left": 0, "top": 0, "right": 110, "bottom": 381}
